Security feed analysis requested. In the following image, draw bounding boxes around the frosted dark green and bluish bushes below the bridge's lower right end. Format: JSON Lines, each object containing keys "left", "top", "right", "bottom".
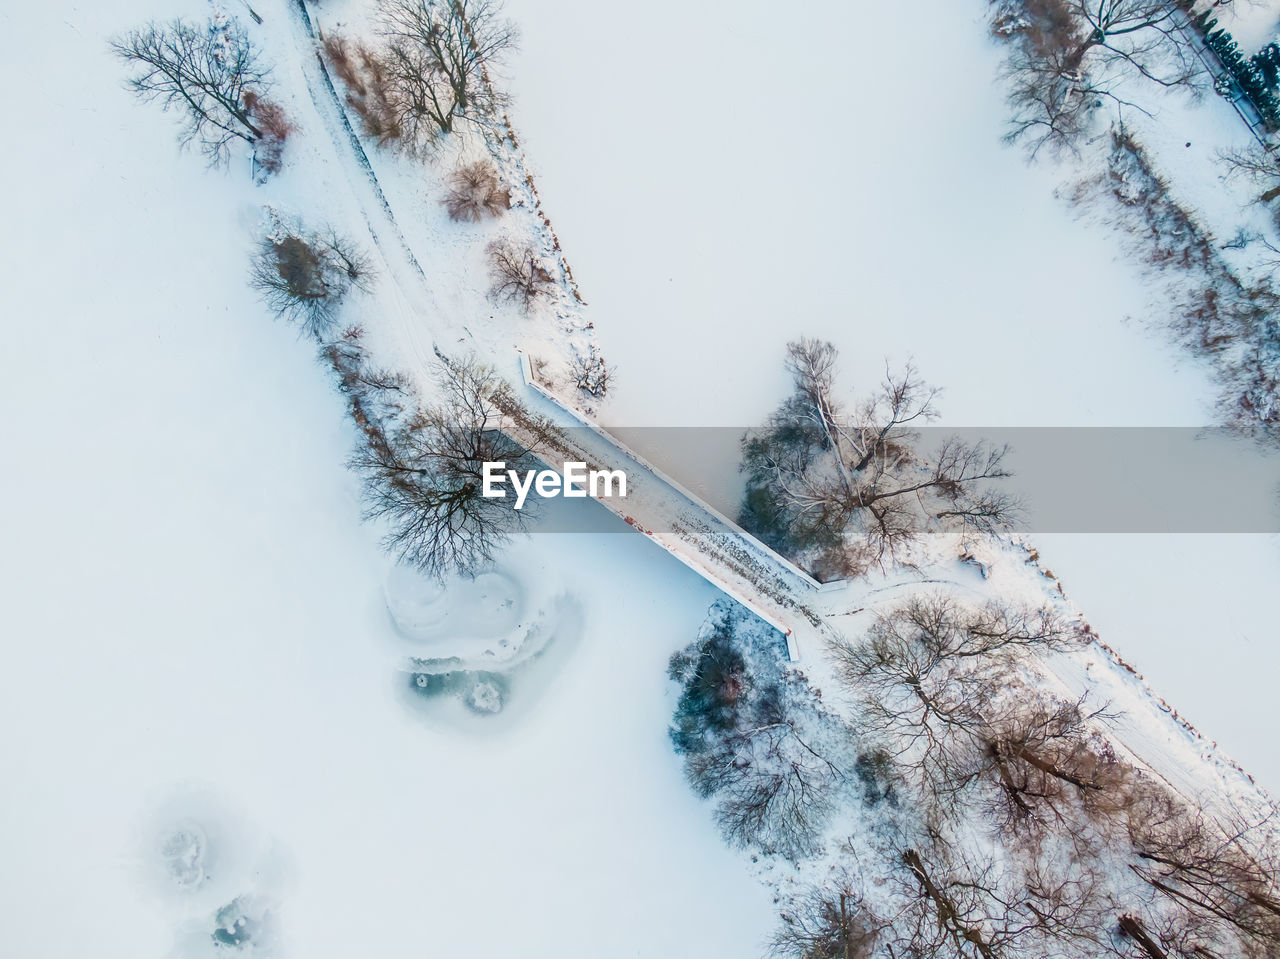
{"left": 669, "top": 600, "right": 847, "bottom": 859}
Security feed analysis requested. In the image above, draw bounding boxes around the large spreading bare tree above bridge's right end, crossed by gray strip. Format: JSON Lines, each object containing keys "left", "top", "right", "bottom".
{"left": 741, "top": 339, "right": 1016, "bottom": 570}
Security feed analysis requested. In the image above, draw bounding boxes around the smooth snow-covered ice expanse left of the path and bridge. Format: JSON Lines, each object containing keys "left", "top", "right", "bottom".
{"left": 0, "top": 0, "right": 772, "bottom": 959}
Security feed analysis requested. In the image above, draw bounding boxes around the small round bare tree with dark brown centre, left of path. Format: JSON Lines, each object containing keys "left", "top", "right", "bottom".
{"left": 250, "top": 220, "right": 372, "bottom": 342}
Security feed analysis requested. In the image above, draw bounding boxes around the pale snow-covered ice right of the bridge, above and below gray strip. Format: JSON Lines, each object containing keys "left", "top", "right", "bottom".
{"left": 508, "top": 0, "right": 1280, "bottom": 794}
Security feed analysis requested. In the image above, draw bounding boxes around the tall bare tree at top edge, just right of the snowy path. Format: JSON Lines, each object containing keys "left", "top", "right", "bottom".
{"left": 379, "top": 0, "right": 517, "bottom": 147}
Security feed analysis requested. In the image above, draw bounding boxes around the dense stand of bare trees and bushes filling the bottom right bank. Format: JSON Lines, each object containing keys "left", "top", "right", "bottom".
{"left": 671, "top": 593, "right": 1280, "bottom": 959}
